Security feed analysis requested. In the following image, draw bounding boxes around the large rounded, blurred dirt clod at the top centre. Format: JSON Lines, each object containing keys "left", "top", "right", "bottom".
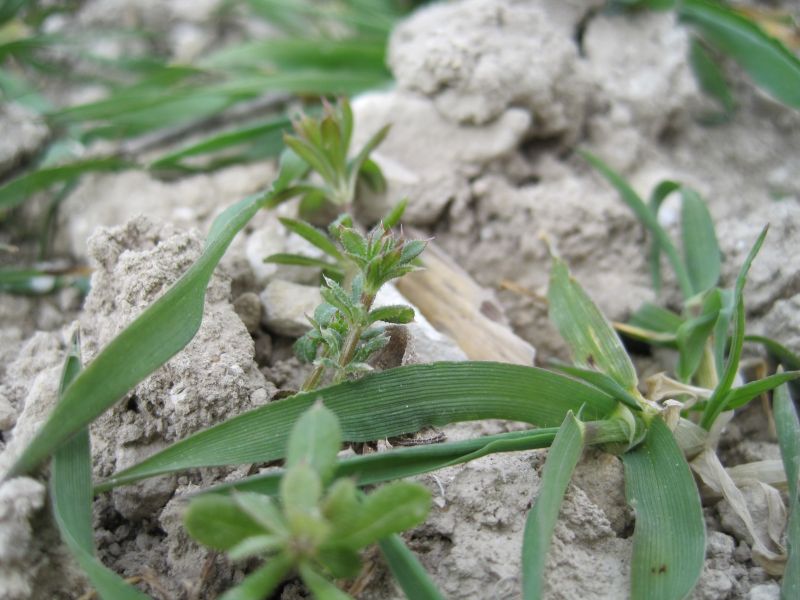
{"left": 389, "top": 0, "right": 589, "bottom": 140}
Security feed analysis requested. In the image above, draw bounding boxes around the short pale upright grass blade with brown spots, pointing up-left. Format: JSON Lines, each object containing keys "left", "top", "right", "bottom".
{"left": 547, "top": 258, "right": 637, "bottom": 395}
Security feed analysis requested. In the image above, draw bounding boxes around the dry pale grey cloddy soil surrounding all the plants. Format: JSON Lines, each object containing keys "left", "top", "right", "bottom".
{"left": 0, "top": 0, "right": 800, "bottom": 600}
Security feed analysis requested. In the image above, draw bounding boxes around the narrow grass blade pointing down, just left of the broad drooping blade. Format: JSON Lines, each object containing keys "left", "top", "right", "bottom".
{"left": 522, "top": 412, "right": 583, "bottom": 600}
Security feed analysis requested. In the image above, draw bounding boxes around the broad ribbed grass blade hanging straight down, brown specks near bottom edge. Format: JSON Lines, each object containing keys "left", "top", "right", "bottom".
{"left": 622, "top": 417, "right": 706, "bottom": 600}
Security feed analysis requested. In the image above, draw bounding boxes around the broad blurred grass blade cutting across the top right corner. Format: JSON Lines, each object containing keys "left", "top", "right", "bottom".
{"left": 678, "top": 0, "right": 800, "bottom": 108}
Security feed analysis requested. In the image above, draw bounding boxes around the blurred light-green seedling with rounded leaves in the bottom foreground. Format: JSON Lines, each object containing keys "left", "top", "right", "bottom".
{"left": 185, "top": 403, "right": 431, "bottom": 600}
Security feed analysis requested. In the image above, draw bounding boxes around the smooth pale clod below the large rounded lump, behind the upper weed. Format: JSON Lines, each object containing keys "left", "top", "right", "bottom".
{"left": 353, "top": 91, "right": 530, "bottom": 225}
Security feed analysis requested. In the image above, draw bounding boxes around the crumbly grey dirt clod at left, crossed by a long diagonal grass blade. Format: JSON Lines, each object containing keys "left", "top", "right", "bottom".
{"left": 82, "top": 217, "right": 275, "bottom": 518}
